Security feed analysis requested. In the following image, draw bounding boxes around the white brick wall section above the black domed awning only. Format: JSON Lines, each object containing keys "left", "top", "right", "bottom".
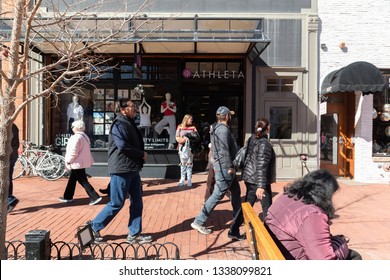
{"left": 318, "top": 0, "right": 390, "bottom": 81}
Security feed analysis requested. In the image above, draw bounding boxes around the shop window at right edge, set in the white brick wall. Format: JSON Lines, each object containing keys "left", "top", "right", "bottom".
{"left": 372, "top": 73, "right": 390, "bottom": 156}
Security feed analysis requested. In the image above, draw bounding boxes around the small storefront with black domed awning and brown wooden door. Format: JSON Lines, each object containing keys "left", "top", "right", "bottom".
{"left": 320, "top": 61, "right": 390, "bottom": 181}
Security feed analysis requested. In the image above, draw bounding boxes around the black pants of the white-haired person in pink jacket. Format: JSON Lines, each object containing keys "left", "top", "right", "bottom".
{"left": 64, "top": 168, "right": 99, "bottom": 200}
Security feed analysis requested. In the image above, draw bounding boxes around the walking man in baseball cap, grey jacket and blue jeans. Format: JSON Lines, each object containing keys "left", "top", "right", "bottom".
{"left": 191, "top": 106, "right": 244, "bottom": 240}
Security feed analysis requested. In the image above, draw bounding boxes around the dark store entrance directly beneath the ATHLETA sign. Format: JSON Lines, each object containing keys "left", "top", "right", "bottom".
{"left": 178, "top": 83, "right": 244, "bottom": 172}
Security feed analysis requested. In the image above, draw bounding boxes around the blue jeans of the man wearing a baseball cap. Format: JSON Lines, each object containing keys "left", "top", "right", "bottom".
{"left": 194, "top": 169, "right": 241, "bottom": 226}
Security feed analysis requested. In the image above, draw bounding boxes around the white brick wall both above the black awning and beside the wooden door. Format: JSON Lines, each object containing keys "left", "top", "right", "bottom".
{"left": 318, "top": 0, "right": 390, "bottom": 183}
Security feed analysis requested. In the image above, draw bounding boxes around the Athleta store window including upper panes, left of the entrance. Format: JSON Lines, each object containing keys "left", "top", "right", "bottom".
{"left": 50, "top": 60, "right": 180, "bottom": 149}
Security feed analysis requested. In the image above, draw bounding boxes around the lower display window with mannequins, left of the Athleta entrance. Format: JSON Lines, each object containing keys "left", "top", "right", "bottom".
{"left": 53, "top": 85, "right": 179, "bottom": 149}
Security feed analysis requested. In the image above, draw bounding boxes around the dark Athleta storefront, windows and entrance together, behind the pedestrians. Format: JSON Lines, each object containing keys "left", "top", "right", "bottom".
{"left": 50, "top": 57, "right": 245, "bottom": 177}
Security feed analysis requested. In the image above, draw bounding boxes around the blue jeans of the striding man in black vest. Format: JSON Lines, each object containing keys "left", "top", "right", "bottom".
{"left": 92, "top": 171, "right": 143, "bottom": 236}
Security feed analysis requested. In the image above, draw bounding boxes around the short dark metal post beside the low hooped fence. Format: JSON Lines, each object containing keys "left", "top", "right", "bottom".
{"left": 26, "top": 230, "right": 51, "bottom": 260}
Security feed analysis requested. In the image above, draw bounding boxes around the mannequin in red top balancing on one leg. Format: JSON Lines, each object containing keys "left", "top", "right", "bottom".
{"left": 154, "top": 92, "right": 177, "bottom": 149}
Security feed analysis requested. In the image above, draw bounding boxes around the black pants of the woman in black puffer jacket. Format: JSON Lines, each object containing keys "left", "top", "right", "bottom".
{"left": 230, "top": 182, "right": 272, "bottom": 235}
